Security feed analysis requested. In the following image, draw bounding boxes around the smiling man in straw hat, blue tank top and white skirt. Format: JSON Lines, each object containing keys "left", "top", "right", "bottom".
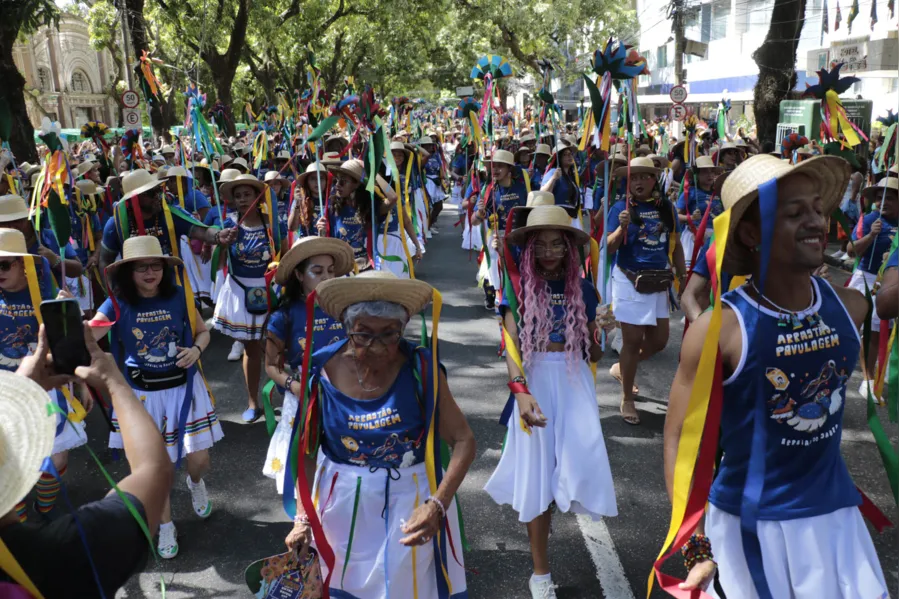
{"left": 664, "top": 155, "right": 889, "bottom": 598}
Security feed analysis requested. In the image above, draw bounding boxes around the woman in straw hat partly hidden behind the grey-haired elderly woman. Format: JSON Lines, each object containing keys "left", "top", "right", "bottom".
{"left": 262, "top": 237, "right": 354, "bottom": 493}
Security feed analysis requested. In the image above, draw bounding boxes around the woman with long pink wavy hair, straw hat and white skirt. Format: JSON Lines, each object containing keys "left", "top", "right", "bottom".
{"left": 485, "top": 204, "right": 617, "bottom": 599}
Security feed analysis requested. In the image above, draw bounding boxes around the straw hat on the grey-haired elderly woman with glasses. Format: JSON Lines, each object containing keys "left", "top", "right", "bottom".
{"left": 316, "top": 270, "right": 434, "bottom": 319}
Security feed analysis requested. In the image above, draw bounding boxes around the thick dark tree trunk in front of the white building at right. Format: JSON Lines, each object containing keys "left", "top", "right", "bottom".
{"left": 752, "top": 0, "right": 806, "bottom": 143}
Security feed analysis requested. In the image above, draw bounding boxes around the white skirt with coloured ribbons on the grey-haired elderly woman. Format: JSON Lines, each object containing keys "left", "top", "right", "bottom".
{"left": 313, "top": 457, "right": 468, "bottom": 599}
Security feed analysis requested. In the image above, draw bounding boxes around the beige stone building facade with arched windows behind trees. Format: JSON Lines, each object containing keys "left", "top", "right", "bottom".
{"left": 13, "top": 15, "right": 119, "bottom": 129}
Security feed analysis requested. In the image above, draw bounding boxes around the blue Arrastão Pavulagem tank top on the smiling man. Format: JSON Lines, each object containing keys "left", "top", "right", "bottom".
{"left": 709, "top": 277, "right": 861, "bottom": 520}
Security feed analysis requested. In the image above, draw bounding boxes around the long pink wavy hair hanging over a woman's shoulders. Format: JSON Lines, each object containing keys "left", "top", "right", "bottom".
{"left": 518, "top": 233, "right": 590, "bottom": 368}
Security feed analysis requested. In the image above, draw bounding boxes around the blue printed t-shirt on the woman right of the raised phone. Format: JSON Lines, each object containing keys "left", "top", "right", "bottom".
{"left": 99, "top": 287, "right": 190, "bottom": 372}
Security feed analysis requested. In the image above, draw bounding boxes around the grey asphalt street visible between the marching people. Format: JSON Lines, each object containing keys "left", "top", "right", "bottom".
{"left": 54, "top": 208, "right": 899, "bottom": 599}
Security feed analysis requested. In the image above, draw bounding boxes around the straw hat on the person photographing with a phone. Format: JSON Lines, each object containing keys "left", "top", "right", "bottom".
{"left": 0, "top": 370, "right": 56, "bottom": 514}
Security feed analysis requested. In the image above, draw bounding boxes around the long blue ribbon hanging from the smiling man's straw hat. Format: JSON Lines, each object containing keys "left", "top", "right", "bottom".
{"left": 740, "top": 180, "right": 777, "bottom": 599}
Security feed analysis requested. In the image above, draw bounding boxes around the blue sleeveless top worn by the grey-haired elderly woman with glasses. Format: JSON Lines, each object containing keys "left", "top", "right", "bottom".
{"left": 315, "top": 343, "right": 428, "bottom": 468}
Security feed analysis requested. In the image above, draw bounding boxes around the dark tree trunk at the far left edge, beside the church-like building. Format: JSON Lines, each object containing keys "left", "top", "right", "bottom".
{"left": 0, "top": 27, "right": 38, "bottom": 164}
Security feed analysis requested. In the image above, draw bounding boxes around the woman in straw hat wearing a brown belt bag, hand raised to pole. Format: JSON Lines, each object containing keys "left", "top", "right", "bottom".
{"left": 606, "top": 158, "right": 686, "bottom": 424}
